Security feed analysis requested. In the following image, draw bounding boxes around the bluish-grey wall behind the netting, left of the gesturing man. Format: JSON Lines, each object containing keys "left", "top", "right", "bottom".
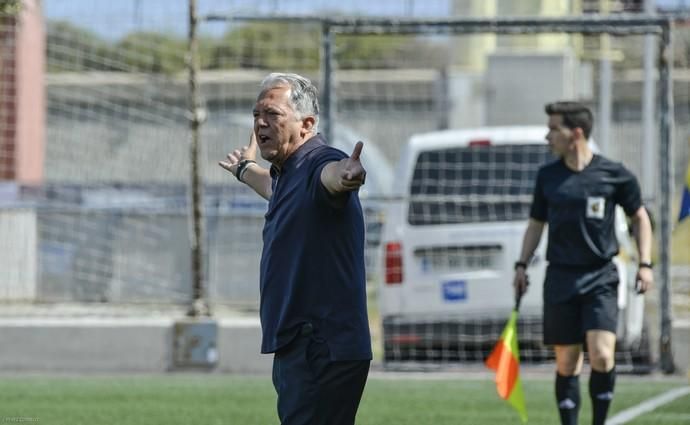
{"left": 35, "top": 210, "right": 263, "bottom": 306}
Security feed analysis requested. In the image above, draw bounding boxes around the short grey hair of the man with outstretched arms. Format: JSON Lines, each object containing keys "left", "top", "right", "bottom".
{"left": 261, "top": 72, "right": 319, "bottom": 133}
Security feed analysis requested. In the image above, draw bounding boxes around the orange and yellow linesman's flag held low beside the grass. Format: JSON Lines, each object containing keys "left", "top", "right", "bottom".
{"left": 485, "top": 308, "right": 527, "bottom": 422}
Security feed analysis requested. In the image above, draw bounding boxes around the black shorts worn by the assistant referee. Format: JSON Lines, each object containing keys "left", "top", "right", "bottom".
{"left": 543, "top": 263, "right": 618, "bottom": 345}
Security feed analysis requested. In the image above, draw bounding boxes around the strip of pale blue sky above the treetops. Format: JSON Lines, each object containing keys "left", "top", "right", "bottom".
{"left": 43, "top": 0, "right": 690, "bottom": 39}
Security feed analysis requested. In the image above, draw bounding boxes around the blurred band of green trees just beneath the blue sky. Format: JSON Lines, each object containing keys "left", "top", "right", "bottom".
{"left": 47, "top": 21, "right": 448, "bottom": 75}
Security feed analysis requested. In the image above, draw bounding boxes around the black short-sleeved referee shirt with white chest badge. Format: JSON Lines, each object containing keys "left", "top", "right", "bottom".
{"left": 530, "top": 155, "right": 642, "bottom": 268}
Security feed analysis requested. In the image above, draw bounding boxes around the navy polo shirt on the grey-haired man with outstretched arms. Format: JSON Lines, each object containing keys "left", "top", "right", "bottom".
{"left": 260, "top": 135, "right": 371, "bottom": 360}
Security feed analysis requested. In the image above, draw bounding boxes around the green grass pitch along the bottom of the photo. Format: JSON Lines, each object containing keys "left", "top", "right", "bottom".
{"left": 0, "top": 373, "right": 690, "bottom": 425}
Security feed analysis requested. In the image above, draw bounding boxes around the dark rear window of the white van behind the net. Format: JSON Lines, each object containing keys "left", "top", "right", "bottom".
{"left": 408, "top": 142, "right": 555, "bottom": 225}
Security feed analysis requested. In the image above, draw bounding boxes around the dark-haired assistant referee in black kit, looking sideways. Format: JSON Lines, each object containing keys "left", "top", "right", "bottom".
{"left": 514, "top": 102, "right": 653, "bottom": 425}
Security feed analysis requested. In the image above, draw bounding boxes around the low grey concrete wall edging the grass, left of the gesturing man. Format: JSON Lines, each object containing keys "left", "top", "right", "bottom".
{"left": 0, "top": 317, "right": 273, "bottom": 373}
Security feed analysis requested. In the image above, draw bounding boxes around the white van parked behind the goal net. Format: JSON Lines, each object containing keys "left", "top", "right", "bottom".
{"left": 378, "top": 126, "right": 649, "bottom": 367}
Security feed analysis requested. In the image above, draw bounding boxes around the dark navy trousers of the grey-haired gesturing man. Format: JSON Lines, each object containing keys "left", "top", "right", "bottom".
{"left": 273, "top": 334, "right": 370, "bottom": 425}
